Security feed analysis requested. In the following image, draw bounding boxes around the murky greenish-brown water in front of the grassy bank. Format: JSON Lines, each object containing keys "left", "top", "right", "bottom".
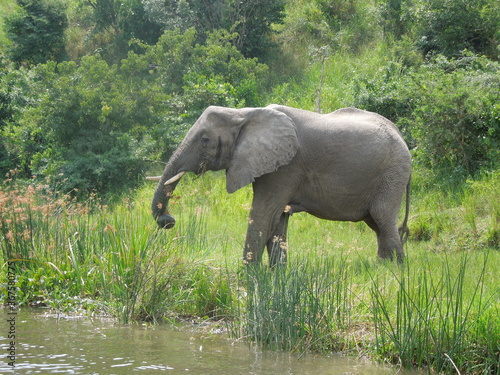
{"left": 0, "top": 308, "right": 416, "bottom": 375}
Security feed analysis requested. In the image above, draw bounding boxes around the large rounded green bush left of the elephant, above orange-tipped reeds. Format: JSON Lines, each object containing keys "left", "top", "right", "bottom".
{"left": 4, "top": 57, "right": 161, "bottom": 193}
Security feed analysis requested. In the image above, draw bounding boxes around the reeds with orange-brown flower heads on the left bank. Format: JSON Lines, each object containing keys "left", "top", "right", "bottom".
{"left": 0, "top": 178, "right": 186, "bottom": 322}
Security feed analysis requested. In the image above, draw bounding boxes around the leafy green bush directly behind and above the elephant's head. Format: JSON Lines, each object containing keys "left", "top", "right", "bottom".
{"left": 137, "top": 29, "right": 268, "bottom": 159}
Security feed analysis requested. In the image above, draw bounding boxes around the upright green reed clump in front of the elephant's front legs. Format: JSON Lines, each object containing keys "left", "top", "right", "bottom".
{"left": 243, "top": 257, "right": 353, "bottom": 352}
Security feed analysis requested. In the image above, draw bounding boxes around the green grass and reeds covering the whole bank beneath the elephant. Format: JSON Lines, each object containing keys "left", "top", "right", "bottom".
{"left": 0, "top": 171, "right": 500, "bottom": 374}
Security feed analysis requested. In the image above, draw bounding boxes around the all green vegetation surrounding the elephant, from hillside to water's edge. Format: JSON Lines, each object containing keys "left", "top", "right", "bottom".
{"left": 0, "top": 0, "right": 500, "bottom": 374}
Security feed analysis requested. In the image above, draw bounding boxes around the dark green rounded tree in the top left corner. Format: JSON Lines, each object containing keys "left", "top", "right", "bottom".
{"left": 5, "top": 0, "right": 68, "bottom": 65}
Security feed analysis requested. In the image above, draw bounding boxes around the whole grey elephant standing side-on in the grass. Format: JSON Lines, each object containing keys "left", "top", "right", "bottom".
{"left": 152, "top": 105, "right": 411, "bottom": 265}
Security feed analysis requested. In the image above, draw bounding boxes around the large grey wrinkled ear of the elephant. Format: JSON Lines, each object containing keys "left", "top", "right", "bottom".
{"left": 226, "top": 108, "right": 299, "bottom": 193}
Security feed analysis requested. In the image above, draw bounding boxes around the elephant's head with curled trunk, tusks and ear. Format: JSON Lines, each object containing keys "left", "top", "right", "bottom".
{"left": 151, "top": 107, "right": 298, "bottom": 228}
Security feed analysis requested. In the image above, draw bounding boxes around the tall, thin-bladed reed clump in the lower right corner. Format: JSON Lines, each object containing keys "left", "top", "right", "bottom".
{"left": 371, "top": 253, "right": 500, "bottom": 373}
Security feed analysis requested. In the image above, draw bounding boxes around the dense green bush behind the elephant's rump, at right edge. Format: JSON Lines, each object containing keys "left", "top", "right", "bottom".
{"left": 356, "top": 54, "right": 500, "bottom": 179}
